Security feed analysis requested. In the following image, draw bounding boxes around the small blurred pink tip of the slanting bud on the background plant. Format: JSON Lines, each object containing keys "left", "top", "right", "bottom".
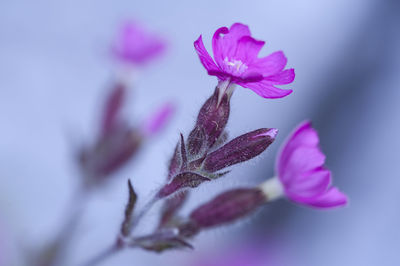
{"left": 142, "top": 103, "right": 175, "bottom": 137}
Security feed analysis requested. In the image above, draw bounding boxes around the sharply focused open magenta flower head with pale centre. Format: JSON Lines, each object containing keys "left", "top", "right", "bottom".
{"left": 194, "top": 23, "right": 295, "bottom": 98}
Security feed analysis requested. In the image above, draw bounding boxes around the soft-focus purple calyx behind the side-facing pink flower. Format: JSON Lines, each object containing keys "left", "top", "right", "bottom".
{"left": 190, "top": 188, "right": 266, "bottom": 228}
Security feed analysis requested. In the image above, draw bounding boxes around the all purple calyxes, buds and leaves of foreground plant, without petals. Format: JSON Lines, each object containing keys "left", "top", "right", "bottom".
{"left": 118, "top": 87, "right": 278, "bottom": 252}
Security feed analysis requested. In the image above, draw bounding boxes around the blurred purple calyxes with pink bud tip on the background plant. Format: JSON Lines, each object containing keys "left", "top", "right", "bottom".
{"left": 79, "top": 83, "right": 174, "bottom": 185}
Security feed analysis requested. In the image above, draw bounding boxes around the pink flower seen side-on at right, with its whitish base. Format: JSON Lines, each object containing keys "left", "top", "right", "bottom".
{"left": 260, "top": 121, "right": 348, "bottom": 208}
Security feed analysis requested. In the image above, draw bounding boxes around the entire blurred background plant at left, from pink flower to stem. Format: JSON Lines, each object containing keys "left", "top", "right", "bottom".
{"left": 27, "top": 21, "right": 175, "bottom": 266}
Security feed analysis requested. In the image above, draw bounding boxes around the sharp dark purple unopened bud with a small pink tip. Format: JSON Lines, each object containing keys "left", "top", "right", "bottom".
{"left": 203, "top": 128, "right": 278, "bottom": 172}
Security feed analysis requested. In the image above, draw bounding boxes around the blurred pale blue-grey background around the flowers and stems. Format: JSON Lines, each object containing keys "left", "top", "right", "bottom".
{"left": 0, "top": 0, "right": 400, "bottom": 266}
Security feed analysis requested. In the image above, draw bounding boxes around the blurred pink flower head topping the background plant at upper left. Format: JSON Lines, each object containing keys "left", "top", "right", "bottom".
{"left": 112, "top": 21, "right": 166, "bottom": 65}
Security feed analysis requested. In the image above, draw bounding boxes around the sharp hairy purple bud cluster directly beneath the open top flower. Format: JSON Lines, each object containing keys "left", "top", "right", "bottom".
{"left": 157, "top": 88, "right": 277, "bottom": 198}
